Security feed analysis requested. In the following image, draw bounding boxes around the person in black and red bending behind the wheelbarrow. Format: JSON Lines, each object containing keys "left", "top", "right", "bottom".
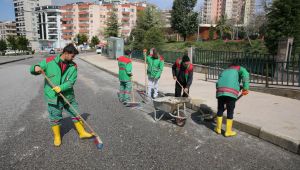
{"left": 172, "top": 54, "right": 193, "bottom": 97}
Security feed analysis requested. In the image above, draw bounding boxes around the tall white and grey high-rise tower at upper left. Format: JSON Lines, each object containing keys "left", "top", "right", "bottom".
{"left": 13, "top": 0, "right": 52, "bottom": 50}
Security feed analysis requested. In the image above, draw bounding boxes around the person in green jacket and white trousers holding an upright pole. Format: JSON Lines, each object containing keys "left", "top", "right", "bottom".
{"left": 146, "top": 48, "right": 164, "bottom": 99}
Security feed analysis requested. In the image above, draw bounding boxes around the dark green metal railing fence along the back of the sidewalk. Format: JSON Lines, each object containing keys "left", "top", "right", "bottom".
{"left": 131, "top": 49, "right": 300, "bottom": 86}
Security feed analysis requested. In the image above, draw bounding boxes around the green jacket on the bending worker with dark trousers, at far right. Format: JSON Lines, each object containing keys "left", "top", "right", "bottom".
{"left": 216, "top": 66, "right": 249, "bottom": 99}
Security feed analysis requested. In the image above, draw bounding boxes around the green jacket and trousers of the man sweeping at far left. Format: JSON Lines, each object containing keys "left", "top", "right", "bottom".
{"left": 30, "top": 55, "right": 79, "bottom": 126}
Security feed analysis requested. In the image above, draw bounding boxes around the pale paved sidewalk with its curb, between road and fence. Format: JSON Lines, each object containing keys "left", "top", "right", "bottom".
{"left": 79, "top": 54, "right": 300, "bottom": 154}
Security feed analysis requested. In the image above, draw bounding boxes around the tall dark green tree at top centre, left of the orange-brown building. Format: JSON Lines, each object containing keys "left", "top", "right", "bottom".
{"left": 171, "top": 0, "right": 198, "bottom": 41}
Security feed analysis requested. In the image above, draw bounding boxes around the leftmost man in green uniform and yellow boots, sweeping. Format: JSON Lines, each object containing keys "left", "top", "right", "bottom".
{"left": 30, "top": 44, "right": 93, "bottom": 146}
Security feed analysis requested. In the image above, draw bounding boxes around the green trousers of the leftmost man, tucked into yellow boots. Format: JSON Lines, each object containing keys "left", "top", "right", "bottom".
{"left": 48, "top": 97, "right": 80, "bottom": 126}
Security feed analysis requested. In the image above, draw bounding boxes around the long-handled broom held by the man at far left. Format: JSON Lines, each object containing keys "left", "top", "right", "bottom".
{"left": 42, "top": 70, "right": 103, "bottom": 150}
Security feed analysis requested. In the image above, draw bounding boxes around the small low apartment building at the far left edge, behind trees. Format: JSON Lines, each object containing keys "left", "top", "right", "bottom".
{"left": 0, "top": 21, "right": 17, "bottom": 40}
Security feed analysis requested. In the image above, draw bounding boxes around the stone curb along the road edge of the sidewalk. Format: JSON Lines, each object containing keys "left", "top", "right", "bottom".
{"left": 79, "top": 57, "right": 300, "bottom": 155}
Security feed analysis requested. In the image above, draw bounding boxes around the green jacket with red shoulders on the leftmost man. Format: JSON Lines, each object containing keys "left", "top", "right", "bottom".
{"left": 30, "top": 55, "right": 77, "bottom": 104}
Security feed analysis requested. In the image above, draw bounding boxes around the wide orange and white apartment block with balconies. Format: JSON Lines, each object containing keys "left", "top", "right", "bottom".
{"left": 61, "top": 3, "right": 144, "bottom": 40}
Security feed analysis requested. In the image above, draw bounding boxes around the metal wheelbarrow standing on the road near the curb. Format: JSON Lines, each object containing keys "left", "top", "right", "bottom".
{"left": 153, "top": 96, "right": 190, "bottom": 127}
